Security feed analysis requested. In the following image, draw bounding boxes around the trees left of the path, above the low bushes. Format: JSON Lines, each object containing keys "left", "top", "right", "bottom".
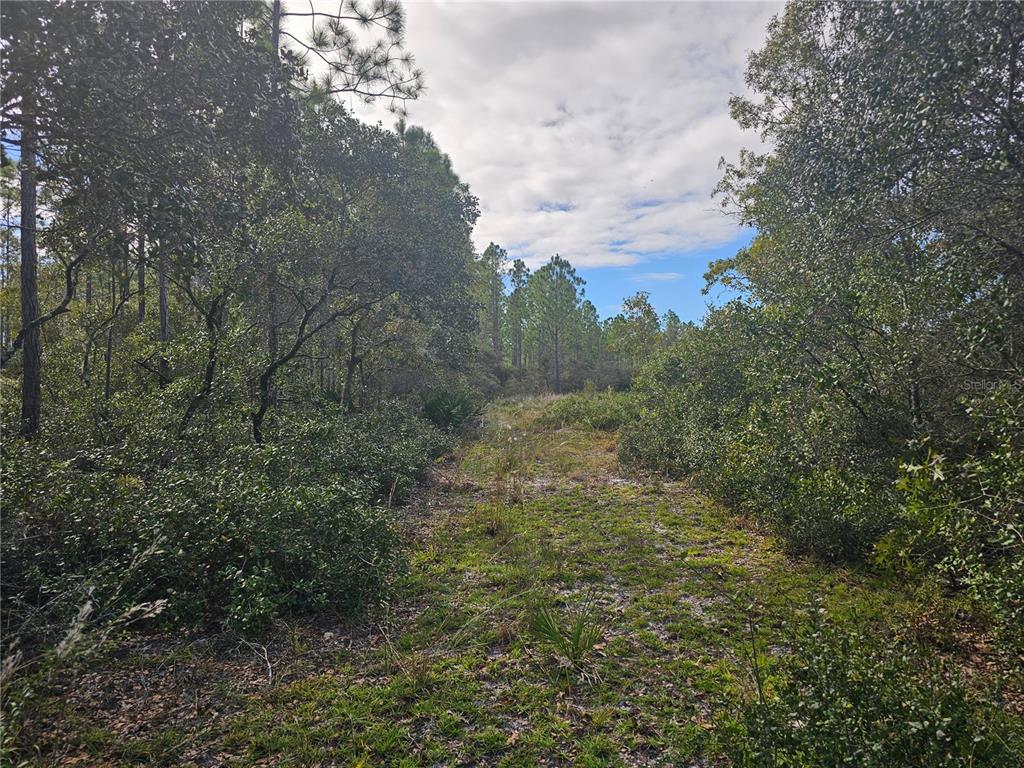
{"left": 2, "top": 2, "right": 477, "bottom": 440}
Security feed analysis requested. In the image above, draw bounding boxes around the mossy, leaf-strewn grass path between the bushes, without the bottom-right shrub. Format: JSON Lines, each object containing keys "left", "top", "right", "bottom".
{"left": 30, "top": 399, "right": 1007, "bottom": 766}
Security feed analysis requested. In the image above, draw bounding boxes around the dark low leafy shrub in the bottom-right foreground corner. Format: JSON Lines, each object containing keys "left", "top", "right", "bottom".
{"left": 732, "top": 613, "right": 1022, "bottom": 768}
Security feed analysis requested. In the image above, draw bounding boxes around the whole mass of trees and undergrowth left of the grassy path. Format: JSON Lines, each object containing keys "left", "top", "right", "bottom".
{"left": 0, "top": 0, "right": 495, "bottom": 696}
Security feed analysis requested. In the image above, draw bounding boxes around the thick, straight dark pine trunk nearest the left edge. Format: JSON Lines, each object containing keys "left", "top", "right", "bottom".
{"left": 20, "top": 119, "right": 43, "bottom": 437}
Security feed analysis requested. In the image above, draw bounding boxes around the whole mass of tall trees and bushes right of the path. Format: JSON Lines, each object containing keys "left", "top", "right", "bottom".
{"left": 622, "top": 0, "right": 1024, "bottom": 649}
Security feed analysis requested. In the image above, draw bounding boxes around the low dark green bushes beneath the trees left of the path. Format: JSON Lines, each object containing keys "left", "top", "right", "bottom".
{"left": 3, "top": 407, "right": 447, "bottom": 647}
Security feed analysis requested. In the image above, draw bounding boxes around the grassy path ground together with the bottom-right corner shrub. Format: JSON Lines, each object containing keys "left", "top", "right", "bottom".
{"left": 9, "top": 398, "right": 1024, "bottom": 766}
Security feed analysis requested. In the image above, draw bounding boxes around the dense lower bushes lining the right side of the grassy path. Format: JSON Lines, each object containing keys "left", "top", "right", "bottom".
{"left": 620, "top": 306, "right": 1024, "bottom": 647}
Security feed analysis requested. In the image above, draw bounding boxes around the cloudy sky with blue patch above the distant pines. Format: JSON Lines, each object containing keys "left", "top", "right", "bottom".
{"left": 307, "top": 0, "right": 779, "bottom": 321}
